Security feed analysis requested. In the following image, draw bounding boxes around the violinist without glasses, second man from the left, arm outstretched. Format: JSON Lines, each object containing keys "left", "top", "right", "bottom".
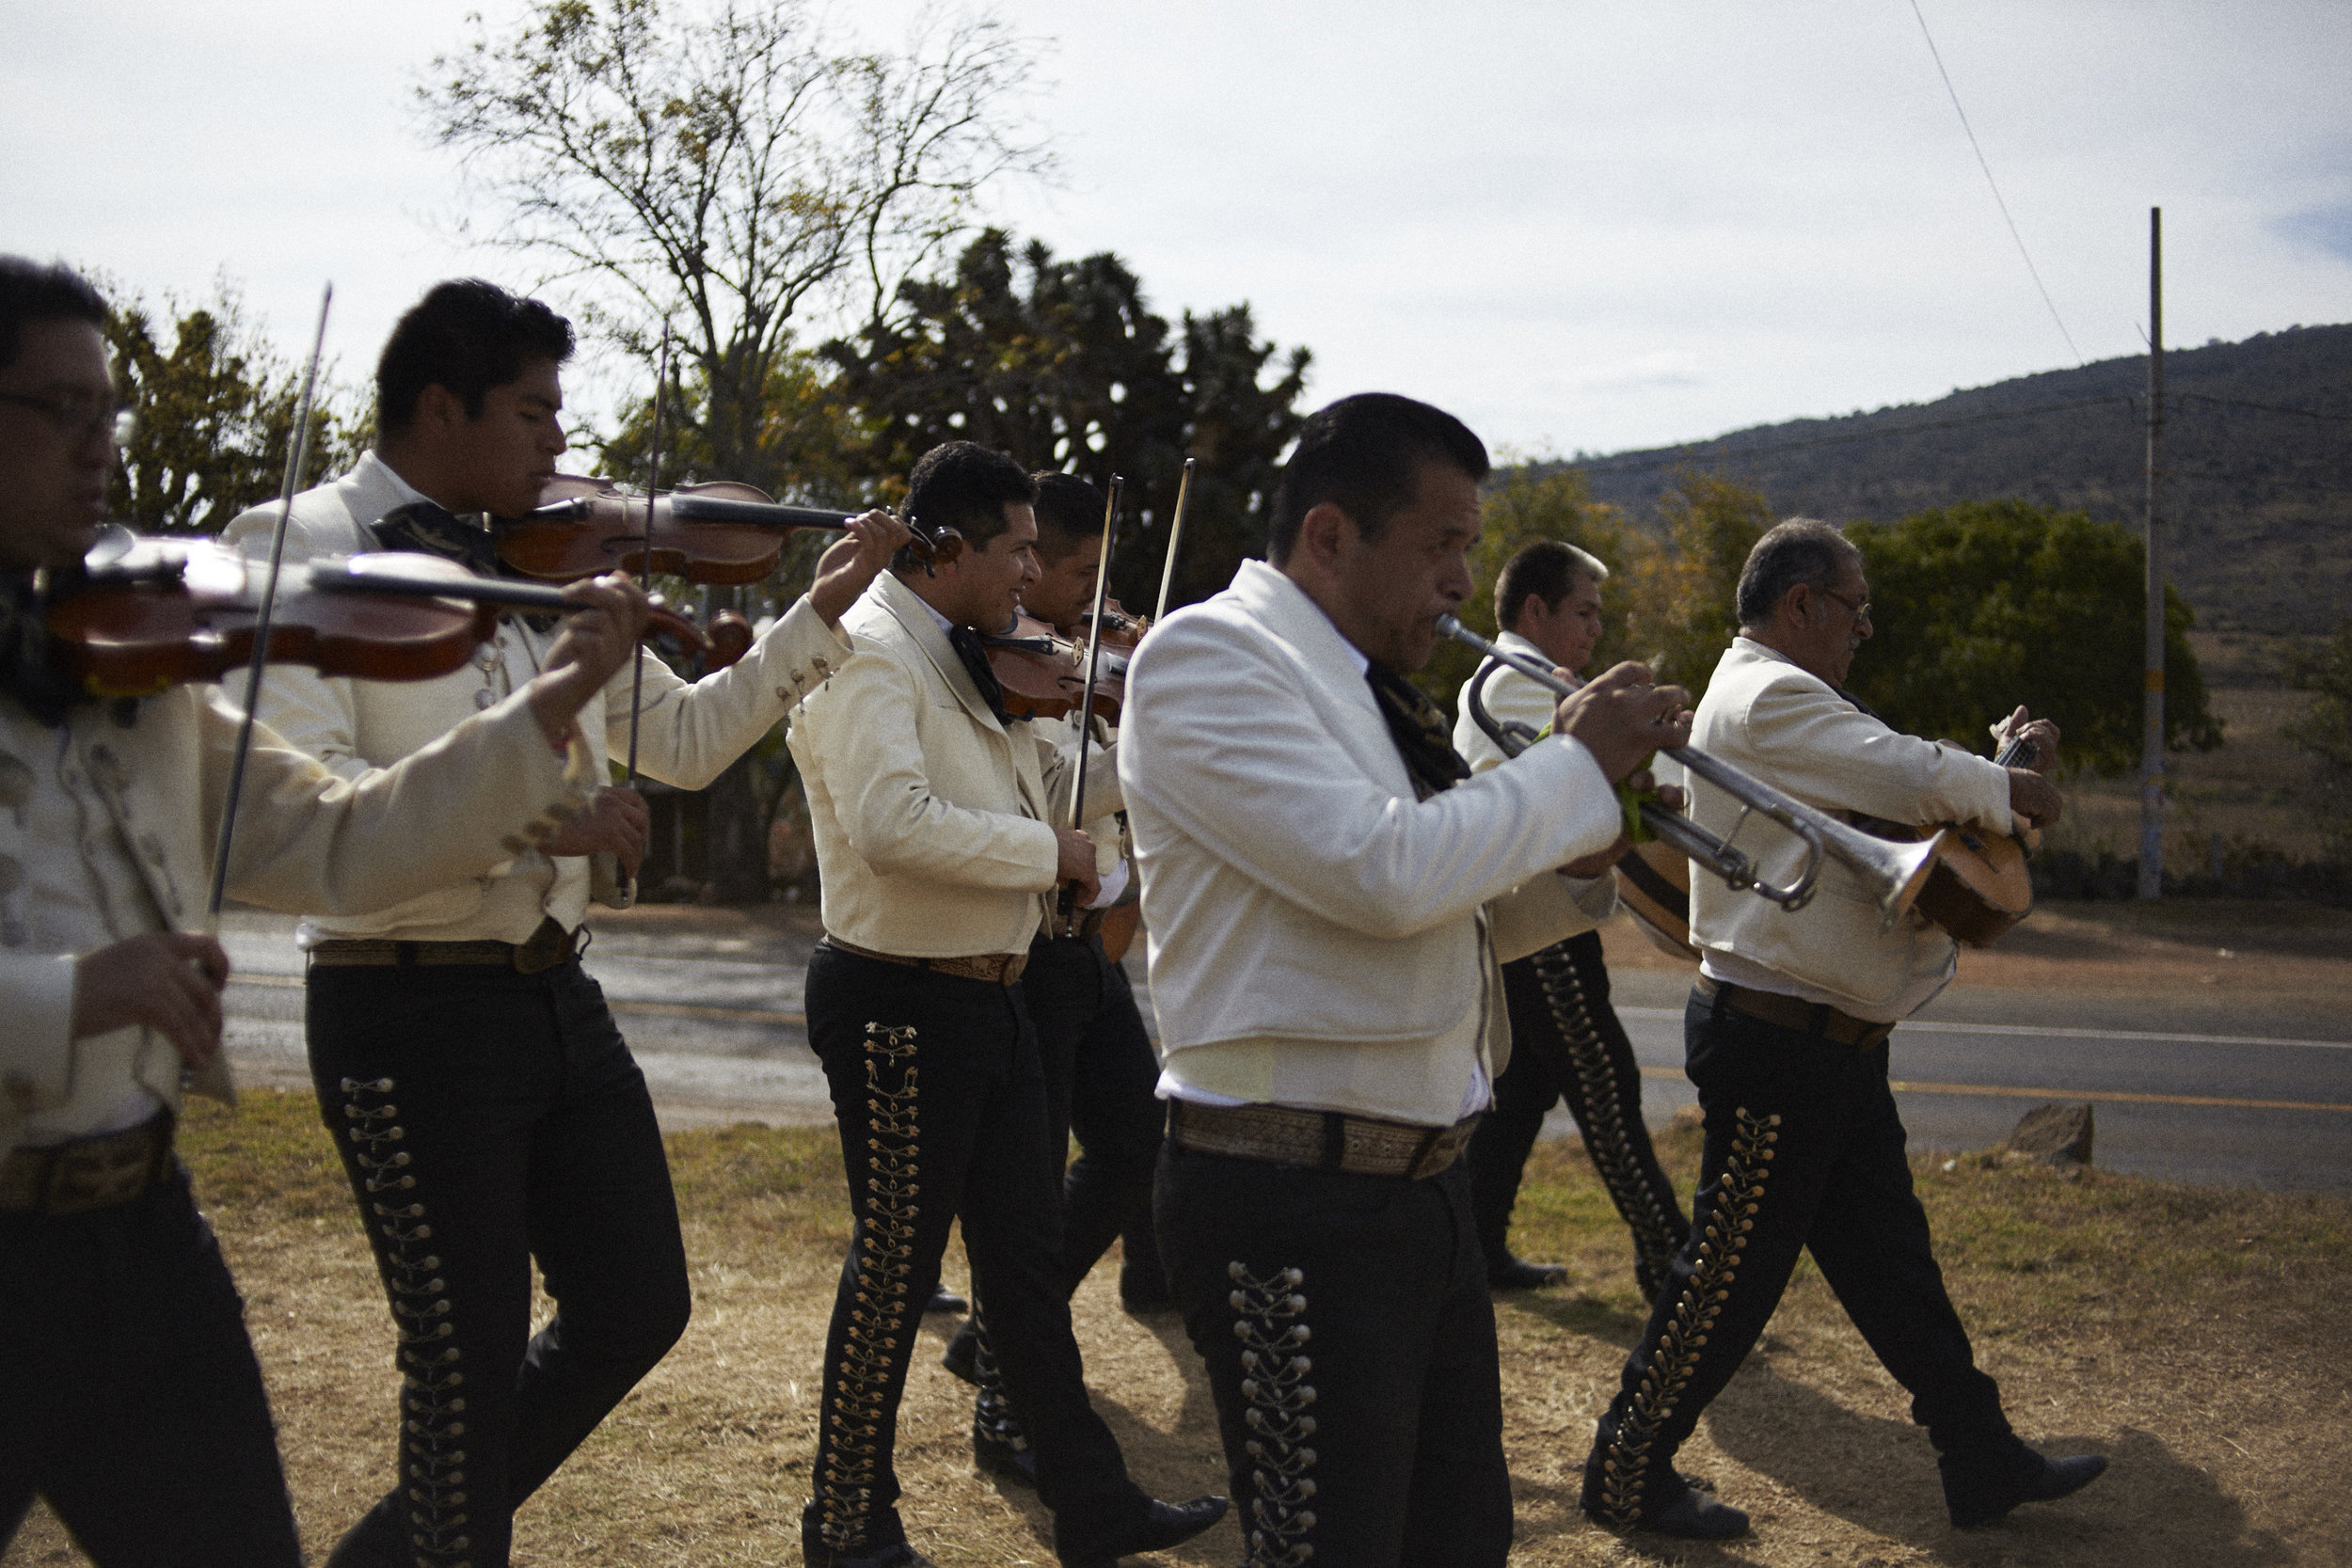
{"left": 229, "top": 279, "right": 906, "bottom": 1568}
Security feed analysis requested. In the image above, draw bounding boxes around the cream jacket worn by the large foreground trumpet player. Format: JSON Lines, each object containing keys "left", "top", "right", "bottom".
{"left": 1120, "top": 562, "right": 1618, "bottom": 1124}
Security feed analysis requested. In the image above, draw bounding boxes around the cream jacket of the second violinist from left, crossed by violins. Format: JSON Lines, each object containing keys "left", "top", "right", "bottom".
{"left": 224, "top": 458, "right": 850, "bottom": 942}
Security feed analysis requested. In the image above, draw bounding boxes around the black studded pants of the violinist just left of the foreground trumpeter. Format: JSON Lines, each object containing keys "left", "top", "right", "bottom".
{"left": 803, "top": 945, "right": 1151, "bottom": 1561}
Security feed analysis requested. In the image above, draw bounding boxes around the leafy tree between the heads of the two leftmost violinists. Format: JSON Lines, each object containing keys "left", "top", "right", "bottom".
{"left": 106, "top": 282, "right": 365, "bottom": 533}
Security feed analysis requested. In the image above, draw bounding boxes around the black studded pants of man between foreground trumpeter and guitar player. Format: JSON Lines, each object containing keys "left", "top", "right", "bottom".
{"left": 1468, "top": 931, "right": 1692, "bottom": 1300}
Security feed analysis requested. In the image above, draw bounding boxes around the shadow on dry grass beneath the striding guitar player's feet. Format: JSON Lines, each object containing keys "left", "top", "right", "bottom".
{"left": 1677, "top": 1361, "right": 2296, "bottom": 1568}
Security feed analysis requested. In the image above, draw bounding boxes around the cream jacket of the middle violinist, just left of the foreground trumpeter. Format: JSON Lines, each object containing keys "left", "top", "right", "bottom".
{"left": 790, "top": 574, "right": 1118, "bottom": 959}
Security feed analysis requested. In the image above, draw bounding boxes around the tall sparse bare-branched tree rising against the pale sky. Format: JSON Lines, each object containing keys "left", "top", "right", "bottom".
{"left": 417, "top": 0, "right": 1049, "bottom": 484}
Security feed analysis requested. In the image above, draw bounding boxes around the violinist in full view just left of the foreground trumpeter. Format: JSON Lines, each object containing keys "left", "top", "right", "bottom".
{"left": 790, "top": 442, "right": 1226, "bottom": 1568}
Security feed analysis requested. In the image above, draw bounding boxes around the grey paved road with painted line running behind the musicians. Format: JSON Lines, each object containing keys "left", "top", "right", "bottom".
{"left": 224, "top": 914, "right": 2352, "bottom": 1195}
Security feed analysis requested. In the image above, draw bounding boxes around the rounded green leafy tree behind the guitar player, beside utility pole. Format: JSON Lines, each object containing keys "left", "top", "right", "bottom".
{"left": 1847, "top": 500, "right": 2220, "bottom": 776}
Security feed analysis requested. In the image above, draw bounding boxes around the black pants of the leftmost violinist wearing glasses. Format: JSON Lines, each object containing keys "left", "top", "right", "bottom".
{"left": 0, "top": 1162, "right": 301, "bottom": 1568}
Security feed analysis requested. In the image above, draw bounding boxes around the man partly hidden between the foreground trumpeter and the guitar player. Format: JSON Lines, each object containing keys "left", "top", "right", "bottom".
{"left": 1454, "top": 538, "right": 1692, "bottom": 1300}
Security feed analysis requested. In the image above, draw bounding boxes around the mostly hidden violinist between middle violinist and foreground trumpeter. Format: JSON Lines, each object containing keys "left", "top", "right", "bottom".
{"left": 941, "top": 472, "right": 1167, "bottom": 1486}
